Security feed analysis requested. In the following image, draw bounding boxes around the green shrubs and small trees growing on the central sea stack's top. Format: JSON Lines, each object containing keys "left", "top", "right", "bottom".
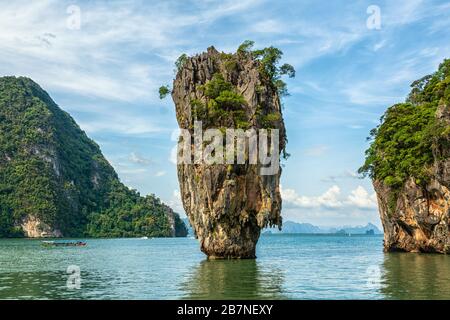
{"left": 158, "top": 40, "right": 295, "bottom": 159}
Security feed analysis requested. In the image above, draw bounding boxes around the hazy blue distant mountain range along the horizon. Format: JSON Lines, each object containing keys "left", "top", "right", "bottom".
{"left": 183, "top": 218, "right": 383, "bottom": 236}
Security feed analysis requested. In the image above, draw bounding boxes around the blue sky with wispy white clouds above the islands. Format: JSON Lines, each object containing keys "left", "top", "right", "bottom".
{"left": 0, "top": 0, "right": 450, "bottom": 226}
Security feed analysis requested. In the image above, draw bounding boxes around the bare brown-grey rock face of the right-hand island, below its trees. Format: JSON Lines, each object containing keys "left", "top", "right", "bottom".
{"left": 374, "top": 105, "right": 450, "bottom": 253}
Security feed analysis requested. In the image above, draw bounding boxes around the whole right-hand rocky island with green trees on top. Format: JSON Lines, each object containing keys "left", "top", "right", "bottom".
{"left": 360, "top": 60, "right": 450, "bottom": 253}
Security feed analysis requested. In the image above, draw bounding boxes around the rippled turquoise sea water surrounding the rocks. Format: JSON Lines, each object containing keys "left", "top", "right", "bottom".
{"left": 0, "top": 235, "right": 450, "bottom": 299}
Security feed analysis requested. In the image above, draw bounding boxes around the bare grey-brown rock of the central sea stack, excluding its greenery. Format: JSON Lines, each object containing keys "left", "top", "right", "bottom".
{"left": 172, "top": 48, "right": 285, "bottom": 258}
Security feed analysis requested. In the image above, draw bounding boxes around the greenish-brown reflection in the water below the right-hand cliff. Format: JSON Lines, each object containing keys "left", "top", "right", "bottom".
{"left": 382, "top": 253, "right": 450, "bottom": 299}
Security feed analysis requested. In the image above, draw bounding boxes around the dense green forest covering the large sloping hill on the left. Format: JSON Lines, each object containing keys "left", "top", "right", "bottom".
{"left": 0, "top": 77, "right": 183, "bottom": 237}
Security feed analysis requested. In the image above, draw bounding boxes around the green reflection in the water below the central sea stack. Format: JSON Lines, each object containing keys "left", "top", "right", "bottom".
{"left": 182, "top": 260, "right": 284, "bottom": 300}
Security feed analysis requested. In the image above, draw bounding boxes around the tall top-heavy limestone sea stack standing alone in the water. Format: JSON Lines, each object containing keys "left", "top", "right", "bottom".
{"left": 172, "top": 46, "right": 292, "bottom": 259}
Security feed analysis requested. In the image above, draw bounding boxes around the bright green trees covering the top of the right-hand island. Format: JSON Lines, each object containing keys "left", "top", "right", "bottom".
{"left": 359, "top": 60, "right": 450, "bottom": 191}
